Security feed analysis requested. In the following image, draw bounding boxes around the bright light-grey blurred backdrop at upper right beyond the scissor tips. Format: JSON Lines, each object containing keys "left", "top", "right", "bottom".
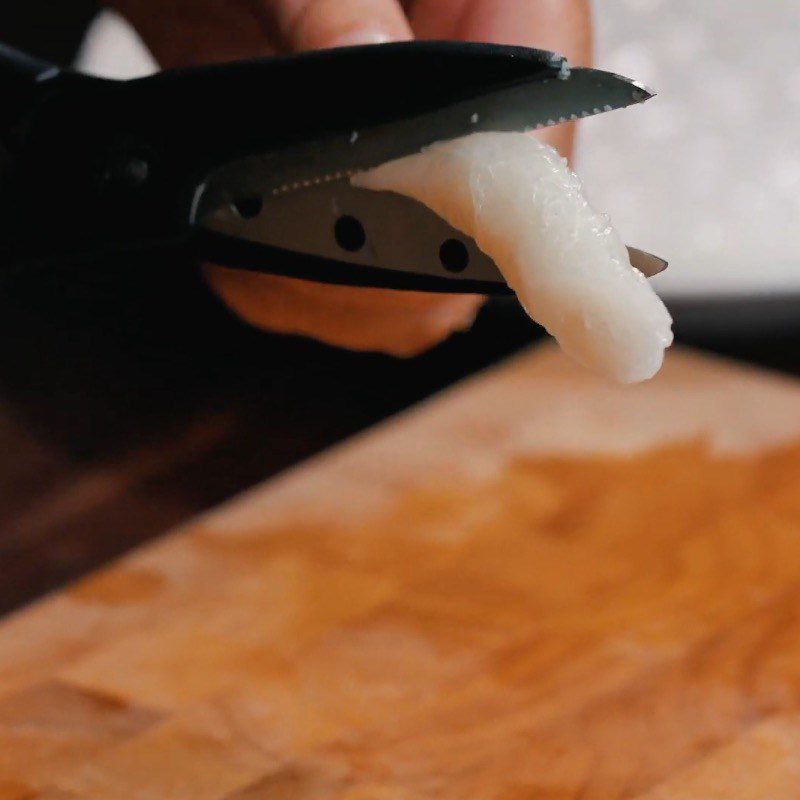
{"left": 579, "top": 0, "right": 800, "bottom": 333}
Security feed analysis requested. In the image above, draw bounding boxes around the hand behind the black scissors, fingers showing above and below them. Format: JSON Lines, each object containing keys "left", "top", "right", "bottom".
{"left": 112, "top": 0, "right": 591, "bottom": 356}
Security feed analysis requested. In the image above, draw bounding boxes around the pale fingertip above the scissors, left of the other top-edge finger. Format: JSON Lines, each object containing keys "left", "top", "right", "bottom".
{"left": 274, "top": 0, "right": 412, "bottom": 50}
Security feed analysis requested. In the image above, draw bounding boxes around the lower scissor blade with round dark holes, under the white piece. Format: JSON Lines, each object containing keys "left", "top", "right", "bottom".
{"left": 198, "top": 180, "right": 666, "bottom": 294}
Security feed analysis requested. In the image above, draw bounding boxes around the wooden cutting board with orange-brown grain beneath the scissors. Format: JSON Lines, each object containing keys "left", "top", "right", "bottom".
{"left": 0, "top": 348, "right": 800, "bottom": 800}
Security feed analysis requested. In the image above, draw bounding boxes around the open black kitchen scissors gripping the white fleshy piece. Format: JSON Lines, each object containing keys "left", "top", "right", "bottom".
{"left": 0, "top": 42, "right": 666, "bottom": 294}
